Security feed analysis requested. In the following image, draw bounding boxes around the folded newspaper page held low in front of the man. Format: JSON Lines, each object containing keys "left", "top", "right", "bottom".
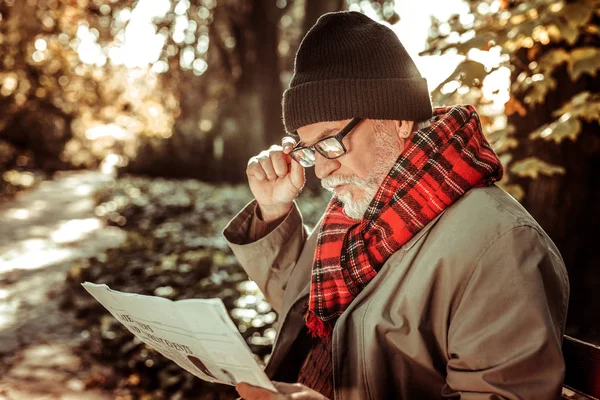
{"left": 82, "top": 282, "right": 277, "bottom": 391}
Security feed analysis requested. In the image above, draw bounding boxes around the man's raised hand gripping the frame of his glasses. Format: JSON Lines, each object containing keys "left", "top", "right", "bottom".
{"left": 246, "top": 137, "right": 306, "bottom": 222}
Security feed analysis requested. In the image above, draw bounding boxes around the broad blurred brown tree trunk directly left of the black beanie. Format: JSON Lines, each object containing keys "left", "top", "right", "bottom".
{"left": 216, "top": 0, "right": 284, "bottom": 181}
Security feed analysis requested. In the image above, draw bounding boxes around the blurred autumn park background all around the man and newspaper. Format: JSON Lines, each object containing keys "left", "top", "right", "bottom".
{"left": 0, "top": 0, "right": 600, "bottom": 399}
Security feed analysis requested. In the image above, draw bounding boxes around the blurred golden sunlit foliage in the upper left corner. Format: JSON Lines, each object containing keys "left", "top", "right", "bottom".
{"left": 0, "top": 0, "right": 177, "bottom": 176}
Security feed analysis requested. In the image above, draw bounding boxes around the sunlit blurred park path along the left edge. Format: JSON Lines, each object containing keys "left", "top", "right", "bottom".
{"left": 0, "top": 171, "right": 124, "bottom": 400}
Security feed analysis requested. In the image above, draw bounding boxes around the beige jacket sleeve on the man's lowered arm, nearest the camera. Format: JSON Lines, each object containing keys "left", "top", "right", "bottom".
{"left": 442, "top": 226, "right": 569, "bottom": 400}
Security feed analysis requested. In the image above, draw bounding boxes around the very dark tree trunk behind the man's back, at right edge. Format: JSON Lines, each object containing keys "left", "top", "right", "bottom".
{"left": 509, "top": 51, "right": 600, "bottom": 340}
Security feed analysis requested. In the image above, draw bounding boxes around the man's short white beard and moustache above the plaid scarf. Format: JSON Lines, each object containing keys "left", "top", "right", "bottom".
{"left": 321, "top": 135, "right": 399, "bottom": 221}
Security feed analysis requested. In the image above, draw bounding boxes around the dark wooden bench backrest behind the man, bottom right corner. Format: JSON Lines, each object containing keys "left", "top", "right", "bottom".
{"left": 563, "top": 335, "right": 600, "bottom": 400}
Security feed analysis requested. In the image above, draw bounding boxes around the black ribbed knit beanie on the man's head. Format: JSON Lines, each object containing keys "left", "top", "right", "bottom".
{"left": 283, "top": 11, "right": 432, "bottom": 133}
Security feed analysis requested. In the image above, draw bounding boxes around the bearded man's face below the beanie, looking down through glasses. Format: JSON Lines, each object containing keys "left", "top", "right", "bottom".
{"left": 298, "top": 119, "right": 412, "bottom": 220}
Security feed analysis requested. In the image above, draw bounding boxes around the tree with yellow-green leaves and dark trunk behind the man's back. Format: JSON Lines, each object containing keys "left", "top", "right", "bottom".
{"left": 423, "top": 0, "right": 600, "bottom": 338}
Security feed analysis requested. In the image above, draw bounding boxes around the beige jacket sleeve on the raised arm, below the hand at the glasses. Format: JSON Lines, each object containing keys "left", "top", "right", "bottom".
{"left": 223, "top": 201, "right": 308, "bottom": 312}
